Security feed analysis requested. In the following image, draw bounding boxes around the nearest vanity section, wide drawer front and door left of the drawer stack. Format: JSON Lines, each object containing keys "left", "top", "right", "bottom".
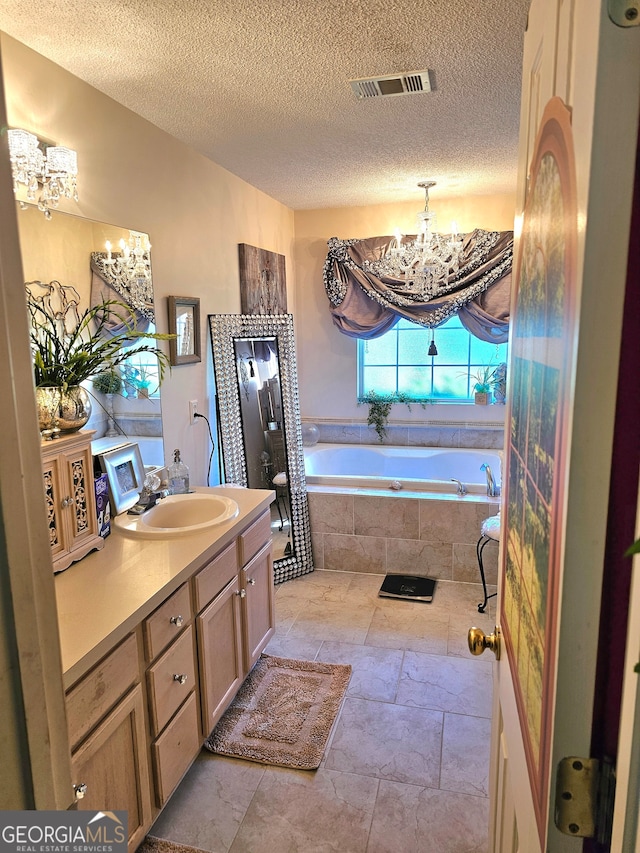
{"left": 67, "top": 634, "right": 152, "bottom": 850}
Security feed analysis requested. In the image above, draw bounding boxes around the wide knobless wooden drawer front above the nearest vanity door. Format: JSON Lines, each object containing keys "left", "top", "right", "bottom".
{"left": 66, "top": 634, "right": 139, "bottom": 750}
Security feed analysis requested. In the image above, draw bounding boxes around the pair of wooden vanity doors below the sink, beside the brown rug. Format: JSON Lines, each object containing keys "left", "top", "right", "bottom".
{"left": 194, "top": 513, "right": 275, "bottom": 737}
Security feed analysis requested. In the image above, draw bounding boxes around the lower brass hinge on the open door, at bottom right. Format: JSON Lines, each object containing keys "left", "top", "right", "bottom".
{"left": 555, "top": 756, "right": 616, "bottom": 845}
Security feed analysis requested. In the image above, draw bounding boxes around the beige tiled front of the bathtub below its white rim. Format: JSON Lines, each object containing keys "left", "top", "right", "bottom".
{"left": 307, "top": 486, "right": 500, "bottom": 584}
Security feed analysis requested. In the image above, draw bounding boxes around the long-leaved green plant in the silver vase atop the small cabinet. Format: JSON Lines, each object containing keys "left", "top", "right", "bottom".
{"left": 27, "top": 290, "right": 175, "bottom": 391}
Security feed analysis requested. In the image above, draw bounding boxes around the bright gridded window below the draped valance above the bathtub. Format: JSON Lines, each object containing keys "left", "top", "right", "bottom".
{"left": 358, "top": 314, "right": 507, "bottom": 402}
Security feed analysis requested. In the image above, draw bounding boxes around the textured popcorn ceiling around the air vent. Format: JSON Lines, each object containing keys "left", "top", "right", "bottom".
{"left": 0, "top": 0, "right": 529, "bottom": 209}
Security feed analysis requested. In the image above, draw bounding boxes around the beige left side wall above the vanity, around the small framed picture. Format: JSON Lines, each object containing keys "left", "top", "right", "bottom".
{"left": 0, "top": 34, "right": 295, "bottom": 485}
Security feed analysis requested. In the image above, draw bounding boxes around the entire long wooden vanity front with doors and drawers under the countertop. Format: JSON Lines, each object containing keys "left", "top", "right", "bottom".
{"left": 63, "top": 506, "right": 275, "bottom": 853}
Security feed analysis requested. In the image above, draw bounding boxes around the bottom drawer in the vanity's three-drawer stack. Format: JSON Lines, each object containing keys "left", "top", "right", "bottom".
{"left": 151, "top": 693, "right": 200, "bottom": 808}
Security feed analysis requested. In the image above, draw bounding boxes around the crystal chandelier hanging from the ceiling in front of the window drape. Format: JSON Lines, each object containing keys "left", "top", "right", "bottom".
{"left": 365, "top": 181, "right": 462, "bottom": 301}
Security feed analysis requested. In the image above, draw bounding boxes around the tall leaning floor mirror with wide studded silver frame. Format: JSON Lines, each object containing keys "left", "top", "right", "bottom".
{"left": 209, "top": 314, "right": 313, "bottom": 583}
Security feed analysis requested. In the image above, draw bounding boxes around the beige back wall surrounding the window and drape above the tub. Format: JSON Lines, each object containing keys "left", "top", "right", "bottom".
{"left": 294, "top": 194, "right": 515, "bottom": 432}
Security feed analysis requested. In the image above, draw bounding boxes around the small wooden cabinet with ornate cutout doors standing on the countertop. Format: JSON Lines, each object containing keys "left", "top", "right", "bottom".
{"left": 41, "top": 432, "right": 104, "bottom": 572}
